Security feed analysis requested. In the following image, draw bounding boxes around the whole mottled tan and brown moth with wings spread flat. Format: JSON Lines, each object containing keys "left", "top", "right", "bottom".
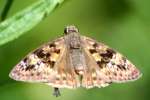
{"left": 9, "top": 25, "right": 142, "bottom": 97}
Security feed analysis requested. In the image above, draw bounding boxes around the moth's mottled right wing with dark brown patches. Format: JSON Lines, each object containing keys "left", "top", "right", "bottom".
{"left": 81, "top": 36, "right": 141, "bottom": 88}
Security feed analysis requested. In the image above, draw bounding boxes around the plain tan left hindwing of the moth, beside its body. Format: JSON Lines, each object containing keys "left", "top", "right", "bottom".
{"left": 47, "top": 49, "right": 80, "bottom": 88}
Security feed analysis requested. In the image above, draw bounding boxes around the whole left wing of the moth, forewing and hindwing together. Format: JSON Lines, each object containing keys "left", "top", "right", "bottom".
{"left": 9, "top": 37, "right": 79, "bottom": 88}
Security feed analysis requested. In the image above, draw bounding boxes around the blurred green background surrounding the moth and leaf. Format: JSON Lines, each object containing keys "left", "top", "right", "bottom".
{"left": 0, "top": 0, "right": 150, "bottom": 100}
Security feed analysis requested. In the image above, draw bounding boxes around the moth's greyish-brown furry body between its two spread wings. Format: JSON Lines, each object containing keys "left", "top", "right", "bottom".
{"left": 64, "top": 27, "right": 86, "bottom": 75}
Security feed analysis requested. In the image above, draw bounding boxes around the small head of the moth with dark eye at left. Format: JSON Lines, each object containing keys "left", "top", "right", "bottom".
{"left": 64, "top": 25, "right": 79, "bottom": 35}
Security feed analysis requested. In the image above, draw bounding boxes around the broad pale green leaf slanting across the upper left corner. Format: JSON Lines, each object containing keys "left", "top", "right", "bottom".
{"left": 0, "top": 0, "right": 64, "bottom": 45}
